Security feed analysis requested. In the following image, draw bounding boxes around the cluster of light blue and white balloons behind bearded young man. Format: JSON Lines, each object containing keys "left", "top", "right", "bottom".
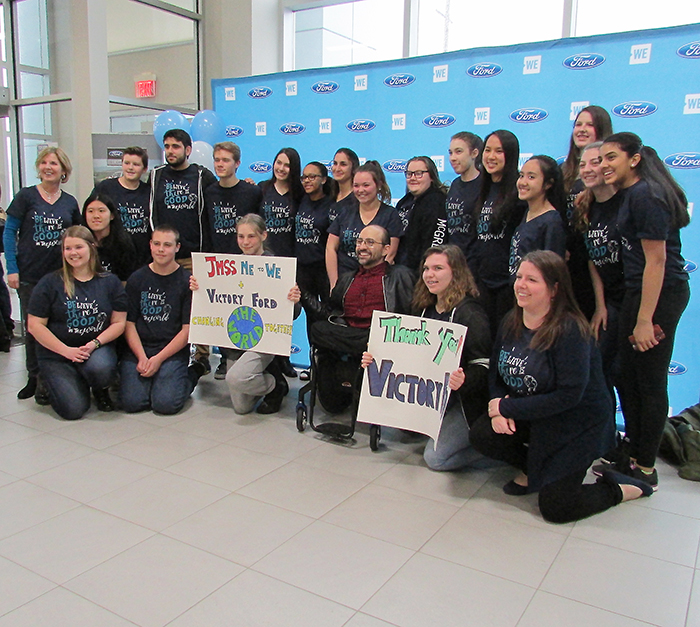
{"left": 153, "top": 109, "right": 226, "bottom": 172}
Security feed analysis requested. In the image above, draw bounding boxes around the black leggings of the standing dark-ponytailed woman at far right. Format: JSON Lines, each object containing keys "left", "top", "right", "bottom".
{"left": 616, "top": 281, "right": 690, "bottom": 468}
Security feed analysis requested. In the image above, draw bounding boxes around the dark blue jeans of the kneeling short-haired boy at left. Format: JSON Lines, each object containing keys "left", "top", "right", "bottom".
{"left": 119, "top": 355, "right": 197, "bottom": 414}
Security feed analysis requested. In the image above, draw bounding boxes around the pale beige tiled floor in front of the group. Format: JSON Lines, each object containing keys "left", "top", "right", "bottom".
{"left": 0, "top": 348, "right": 700, "bottom": 627}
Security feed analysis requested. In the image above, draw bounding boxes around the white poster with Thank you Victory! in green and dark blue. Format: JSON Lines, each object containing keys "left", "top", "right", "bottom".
{"left": 357, "top": 311, "right": 467, "bottom": 441}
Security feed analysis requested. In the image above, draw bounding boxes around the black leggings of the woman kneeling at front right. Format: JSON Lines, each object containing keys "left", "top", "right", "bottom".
{"left": 469, "top": 415, "right": 622, "bottom": 523}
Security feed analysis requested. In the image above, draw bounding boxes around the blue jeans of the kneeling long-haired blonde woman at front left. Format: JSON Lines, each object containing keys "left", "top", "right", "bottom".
{"left": 39, "top": 344, "right": 117, "bottom": 420}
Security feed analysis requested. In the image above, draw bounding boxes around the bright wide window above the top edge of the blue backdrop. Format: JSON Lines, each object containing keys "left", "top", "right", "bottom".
{"left": 292, "top": 0, "right": 700, "bottom": 69}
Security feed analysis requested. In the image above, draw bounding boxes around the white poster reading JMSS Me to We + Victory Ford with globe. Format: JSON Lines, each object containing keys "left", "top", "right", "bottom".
{"left": 189, "top": 253, "right": 296, "bottom": 355}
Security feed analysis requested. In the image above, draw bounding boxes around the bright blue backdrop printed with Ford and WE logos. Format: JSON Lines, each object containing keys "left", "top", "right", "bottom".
{"left": 212, "top": 24, "right": 700, "bottom": 411}
